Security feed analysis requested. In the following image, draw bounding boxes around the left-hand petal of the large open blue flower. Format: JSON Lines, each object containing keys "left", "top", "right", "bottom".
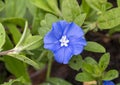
{"left": 44, "top": 30, "right": 58, "bottom": 44}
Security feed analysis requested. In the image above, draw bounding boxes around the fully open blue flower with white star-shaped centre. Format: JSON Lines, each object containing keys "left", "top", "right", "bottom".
{"left": 44, "top": 21, "right": 86, "bottom": 64}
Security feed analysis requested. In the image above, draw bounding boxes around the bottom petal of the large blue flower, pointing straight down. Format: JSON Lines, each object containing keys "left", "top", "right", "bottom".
{"left": 54, "top": 47, "right": 72, "bottom": 64}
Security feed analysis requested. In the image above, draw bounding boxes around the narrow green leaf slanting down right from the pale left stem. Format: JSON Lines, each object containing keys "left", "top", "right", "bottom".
{"left": 8, "top": 53, "right": 40, "bottom": 69}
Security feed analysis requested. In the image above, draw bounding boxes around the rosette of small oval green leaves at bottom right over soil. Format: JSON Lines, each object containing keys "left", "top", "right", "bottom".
{"left": 75, "top": 53, "right": 119, "bottom": 82}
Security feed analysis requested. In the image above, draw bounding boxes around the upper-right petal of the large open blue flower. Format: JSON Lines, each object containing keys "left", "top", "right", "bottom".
{"left": 64, "top": 22, "right": 84, "bottom": 38}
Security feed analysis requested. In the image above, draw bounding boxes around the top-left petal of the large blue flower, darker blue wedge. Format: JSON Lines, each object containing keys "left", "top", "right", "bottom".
{"left": 52, "top": 21, "right": 68, "bottom": 39}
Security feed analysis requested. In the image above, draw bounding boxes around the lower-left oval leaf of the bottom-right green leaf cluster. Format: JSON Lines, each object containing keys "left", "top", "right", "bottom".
{"left": 75, "top": 72, "right": 95, "bottom": 82}
